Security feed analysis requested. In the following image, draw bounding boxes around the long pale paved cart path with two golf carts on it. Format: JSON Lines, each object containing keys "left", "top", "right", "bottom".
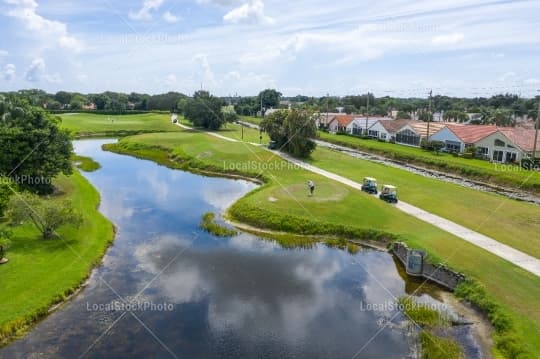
{"left": 178, "top": 124, "right": 540, "bottom": 276}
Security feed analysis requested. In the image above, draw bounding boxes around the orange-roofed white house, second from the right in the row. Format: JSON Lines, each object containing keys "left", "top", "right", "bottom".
{"left": 429, "top": 124, "right": 497, "bottom": 155}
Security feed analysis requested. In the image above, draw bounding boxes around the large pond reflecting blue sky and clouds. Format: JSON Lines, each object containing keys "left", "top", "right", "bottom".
{"left": 0, "top": 140, "right": 480, "bottom": 358}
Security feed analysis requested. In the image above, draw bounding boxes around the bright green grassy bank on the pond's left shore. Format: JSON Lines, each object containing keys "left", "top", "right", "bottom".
{"left": 0, "top": 171, "right": 114, "bottom": 345}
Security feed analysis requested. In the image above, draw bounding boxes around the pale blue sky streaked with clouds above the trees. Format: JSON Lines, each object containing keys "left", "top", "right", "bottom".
{"left": 0, "top": 0, "right": 540, "bottom": 97}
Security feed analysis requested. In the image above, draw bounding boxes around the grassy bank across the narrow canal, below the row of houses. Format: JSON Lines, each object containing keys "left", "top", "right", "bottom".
{"left": 319, "top": 132, "right": 540, "bottom": 194}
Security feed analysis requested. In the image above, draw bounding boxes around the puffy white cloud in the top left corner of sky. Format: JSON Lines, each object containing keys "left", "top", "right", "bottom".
{"left": 4, "top": 0, "right": 83, "bottom": 51}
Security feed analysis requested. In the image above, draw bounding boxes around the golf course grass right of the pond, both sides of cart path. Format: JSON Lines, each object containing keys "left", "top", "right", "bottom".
{"left": 57, "top": 112, "right": 540, "bottom": 358}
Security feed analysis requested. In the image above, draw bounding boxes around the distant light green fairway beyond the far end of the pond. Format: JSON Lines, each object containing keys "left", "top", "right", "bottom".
{"left": 60, "top": 113, "right": 178, "bottom": 136}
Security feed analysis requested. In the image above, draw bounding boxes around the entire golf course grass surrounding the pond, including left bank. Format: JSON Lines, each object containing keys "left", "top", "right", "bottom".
{"left": 0, "top": 113, "right": 540, "bottom": 358}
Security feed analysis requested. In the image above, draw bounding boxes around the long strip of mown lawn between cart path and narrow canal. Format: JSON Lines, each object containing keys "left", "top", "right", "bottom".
{"left": 308, "top": 147, "right": 540, "bottom": 258}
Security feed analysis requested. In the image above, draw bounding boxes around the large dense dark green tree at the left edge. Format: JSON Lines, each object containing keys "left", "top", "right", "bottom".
{"left": 0, "top": 98, "right": 73, "bottom": 193}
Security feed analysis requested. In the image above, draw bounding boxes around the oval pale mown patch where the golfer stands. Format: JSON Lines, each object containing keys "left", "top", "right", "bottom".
{"left": 271, "top": 182, "right": 349, "bottom": 202}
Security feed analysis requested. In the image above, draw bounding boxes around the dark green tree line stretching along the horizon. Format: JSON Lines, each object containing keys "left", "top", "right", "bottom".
{"left": 3, "top": 89, "right": 540, "bottom": 126}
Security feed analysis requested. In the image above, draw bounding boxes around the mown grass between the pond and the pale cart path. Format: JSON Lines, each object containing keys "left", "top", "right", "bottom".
{"left": 107, "top": 131, "right": 540, "bottom": 353}
